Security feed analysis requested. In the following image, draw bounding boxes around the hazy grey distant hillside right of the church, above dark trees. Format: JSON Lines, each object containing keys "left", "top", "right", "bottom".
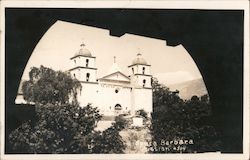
{"left": 168, "top": 78, "right": 207, "bottom": 99}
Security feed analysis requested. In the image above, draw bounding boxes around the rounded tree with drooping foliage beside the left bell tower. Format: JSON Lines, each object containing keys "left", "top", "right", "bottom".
{"left": 22, "top": 66, "right": 81, "bottom": 104}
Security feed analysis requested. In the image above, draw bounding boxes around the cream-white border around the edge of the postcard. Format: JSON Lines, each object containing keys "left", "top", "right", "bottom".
{"left": 0, "top": 0, "right": 250, "bottom": 160}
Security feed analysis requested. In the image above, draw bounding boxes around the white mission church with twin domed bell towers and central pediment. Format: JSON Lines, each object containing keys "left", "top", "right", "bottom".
{"left": 69, "top": 44, "right": 153, "bottom": 116}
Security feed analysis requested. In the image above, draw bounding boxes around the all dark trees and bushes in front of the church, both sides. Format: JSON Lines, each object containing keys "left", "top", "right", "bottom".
{"left": 9, "top": 66, "right": 220, "bottom": 153}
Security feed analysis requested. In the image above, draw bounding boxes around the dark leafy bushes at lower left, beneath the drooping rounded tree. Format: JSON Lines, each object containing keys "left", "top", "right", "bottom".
{"left": 9, "top": 104, "right": 101, "bottom": 153}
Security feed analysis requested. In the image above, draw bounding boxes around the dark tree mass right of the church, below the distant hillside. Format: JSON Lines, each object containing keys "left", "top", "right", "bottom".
{"left": 149, "top": 79, "right": 220, "bottom": 153}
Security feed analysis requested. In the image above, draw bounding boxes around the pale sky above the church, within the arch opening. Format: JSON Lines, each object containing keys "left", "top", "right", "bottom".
{"left": 22, "top": 21, "right": 201, "bottom": 85}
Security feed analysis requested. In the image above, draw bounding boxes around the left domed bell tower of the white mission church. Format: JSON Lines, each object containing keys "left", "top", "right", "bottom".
{"left": 69, "top": 43, "right": 97, "bottom": 83}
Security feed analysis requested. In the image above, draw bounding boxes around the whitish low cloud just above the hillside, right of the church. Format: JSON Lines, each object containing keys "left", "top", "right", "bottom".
{"left": 155, "top": 71, "right": 197, "bottom": 85}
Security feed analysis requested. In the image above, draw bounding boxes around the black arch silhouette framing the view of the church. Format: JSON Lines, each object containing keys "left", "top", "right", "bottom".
{"left": 5, "top": 8, "right": 244, "bottom": 153}
